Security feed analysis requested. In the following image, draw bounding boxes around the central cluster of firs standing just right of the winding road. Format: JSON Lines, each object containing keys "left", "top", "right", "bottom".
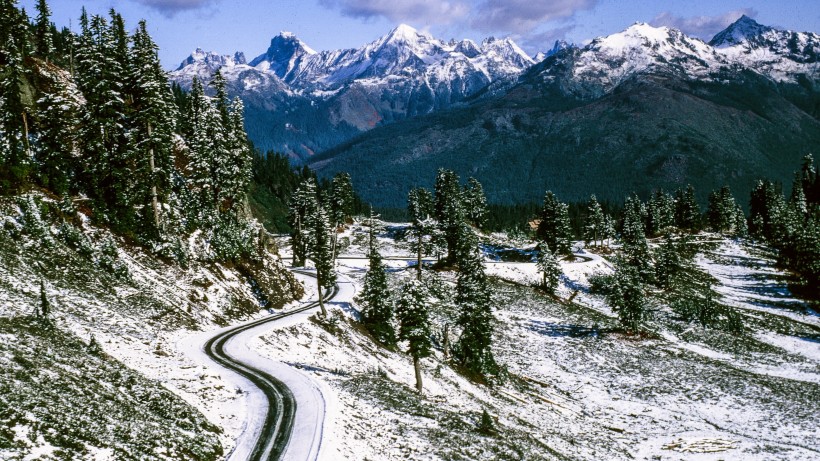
{"left": 358, "top": 169, "right": 499, "bottom": 392}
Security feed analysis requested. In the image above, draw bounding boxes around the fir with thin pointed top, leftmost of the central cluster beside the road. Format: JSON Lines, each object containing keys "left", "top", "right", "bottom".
{"left": 356, "top": 215, "right": 396, "bottom": 345}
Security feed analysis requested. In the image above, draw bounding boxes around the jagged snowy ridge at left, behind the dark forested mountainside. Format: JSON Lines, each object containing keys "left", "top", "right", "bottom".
{"left": 170, "top": 25, "right": 534, "bottom": 159}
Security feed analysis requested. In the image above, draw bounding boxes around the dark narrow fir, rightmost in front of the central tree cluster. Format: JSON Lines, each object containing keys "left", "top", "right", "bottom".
{"left": 453, "top": 224, "right": 498, "bottom": 375}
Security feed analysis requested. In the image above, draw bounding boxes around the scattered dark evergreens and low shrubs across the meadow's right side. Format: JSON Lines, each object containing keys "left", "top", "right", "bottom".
{"left": 572, "top": 155, "right": 820, "bottom": 331}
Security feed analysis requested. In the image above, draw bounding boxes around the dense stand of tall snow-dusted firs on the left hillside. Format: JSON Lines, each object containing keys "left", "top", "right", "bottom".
{"left": 0, "top": 0, "right": 253, "bottom": 260}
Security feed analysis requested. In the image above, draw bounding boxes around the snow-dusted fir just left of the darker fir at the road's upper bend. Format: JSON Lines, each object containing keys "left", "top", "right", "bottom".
{"left": 288, "top": 177, "right": 319, "bottom": 267}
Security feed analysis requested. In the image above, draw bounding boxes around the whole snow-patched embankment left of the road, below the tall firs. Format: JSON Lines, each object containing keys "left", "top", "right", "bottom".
{"left": 0, "top": 193, "right": 302, "bottom": 459}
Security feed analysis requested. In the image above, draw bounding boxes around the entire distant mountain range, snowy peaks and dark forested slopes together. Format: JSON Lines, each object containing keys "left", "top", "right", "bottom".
{"left": 172, "top": 16, "right": 820, "bottom": 206}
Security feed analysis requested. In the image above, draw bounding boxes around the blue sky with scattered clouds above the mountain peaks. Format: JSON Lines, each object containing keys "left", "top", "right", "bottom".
{"left": 19, "top": 0, "right": 820, "bottom": 69}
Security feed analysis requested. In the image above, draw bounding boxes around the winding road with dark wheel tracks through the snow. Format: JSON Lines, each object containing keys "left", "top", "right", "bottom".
{"left": 204, "top": 270, "right": 339, "bottom": 461}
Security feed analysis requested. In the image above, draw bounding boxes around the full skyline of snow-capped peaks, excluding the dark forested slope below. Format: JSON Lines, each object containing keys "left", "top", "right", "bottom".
{"left": 171, "top": 16, "right": 820, "bottom": 164}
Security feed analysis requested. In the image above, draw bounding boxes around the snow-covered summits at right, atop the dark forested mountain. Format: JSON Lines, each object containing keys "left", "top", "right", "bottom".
{"left": 543, "top": 16, "right": 820, "bottom": 98}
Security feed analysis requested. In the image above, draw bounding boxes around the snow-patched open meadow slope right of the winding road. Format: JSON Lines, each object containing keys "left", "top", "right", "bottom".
{"left": 253, "top": 225, "right": 820, "bottom": 460}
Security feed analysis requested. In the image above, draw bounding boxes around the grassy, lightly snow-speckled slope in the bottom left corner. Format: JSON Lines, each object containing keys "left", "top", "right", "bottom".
{"left": 0, "top": 317, "right": 222, "bottom": 460}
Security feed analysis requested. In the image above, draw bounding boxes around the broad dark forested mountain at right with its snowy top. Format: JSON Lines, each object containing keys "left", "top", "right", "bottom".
{"left": 309, "top": 18, "right": 820, "bottom": 207}
